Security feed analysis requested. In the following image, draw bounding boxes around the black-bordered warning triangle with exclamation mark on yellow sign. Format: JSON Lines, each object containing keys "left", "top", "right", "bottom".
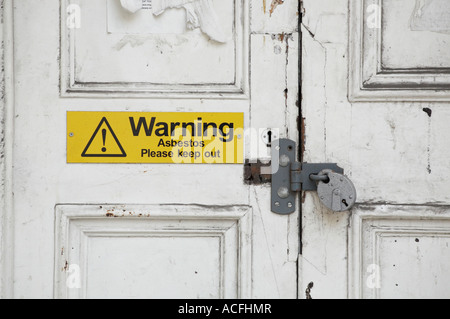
{"left": 81, "top": 117, "right": 127, "bottom": 157}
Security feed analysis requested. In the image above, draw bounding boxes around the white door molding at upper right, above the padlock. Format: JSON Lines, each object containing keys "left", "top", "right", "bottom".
{"left": 348, "top": 0, "right": 450, "bottom": 102}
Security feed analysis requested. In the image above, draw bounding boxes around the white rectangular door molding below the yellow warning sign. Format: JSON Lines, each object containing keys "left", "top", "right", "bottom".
{"left": 54, "top": 204, "right": 252, "bottom": 299}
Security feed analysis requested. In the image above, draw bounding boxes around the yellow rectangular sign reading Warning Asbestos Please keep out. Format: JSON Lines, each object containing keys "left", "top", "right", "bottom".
{"left": 67, "top": 112, "right": 244, "bottom": 164}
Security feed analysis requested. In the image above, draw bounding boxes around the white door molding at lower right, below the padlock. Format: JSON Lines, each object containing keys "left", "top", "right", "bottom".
{"left": 348, "top": 205, "right": 450, "bottom": 299}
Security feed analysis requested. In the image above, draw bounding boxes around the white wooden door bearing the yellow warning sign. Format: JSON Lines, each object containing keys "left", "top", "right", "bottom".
{"left": 1, "top": 0, "right": 299, "bottom": 298}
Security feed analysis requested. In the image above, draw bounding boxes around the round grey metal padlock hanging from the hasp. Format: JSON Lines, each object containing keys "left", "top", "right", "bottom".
{"left": 317, "top": 169, "right": 356, "bottom": 212}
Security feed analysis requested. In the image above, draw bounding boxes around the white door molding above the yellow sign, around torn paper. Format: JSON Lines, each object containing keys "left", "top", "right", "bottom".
{"left": 60, "top": 0, "right": 250, "bottom": 99}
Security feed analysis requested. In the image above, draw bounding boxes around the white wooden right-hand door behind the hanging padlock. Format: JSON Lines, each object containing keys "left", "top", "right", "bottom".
{"left": 299, "top": 0, "right": 450, "bottom": 298}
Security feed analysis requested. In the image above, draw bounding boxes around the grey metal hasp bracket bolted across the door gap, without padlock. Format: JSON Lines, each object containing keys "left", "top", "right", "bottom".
{"left": 271, "top": 139, "right": 344, "bottom": 215}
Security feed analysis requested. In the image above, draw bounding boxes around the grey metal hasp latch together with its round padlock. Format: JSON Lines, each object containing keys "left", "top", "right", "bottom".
{"left": 271, "top": 139, "right": 356, "bottom": 214}
